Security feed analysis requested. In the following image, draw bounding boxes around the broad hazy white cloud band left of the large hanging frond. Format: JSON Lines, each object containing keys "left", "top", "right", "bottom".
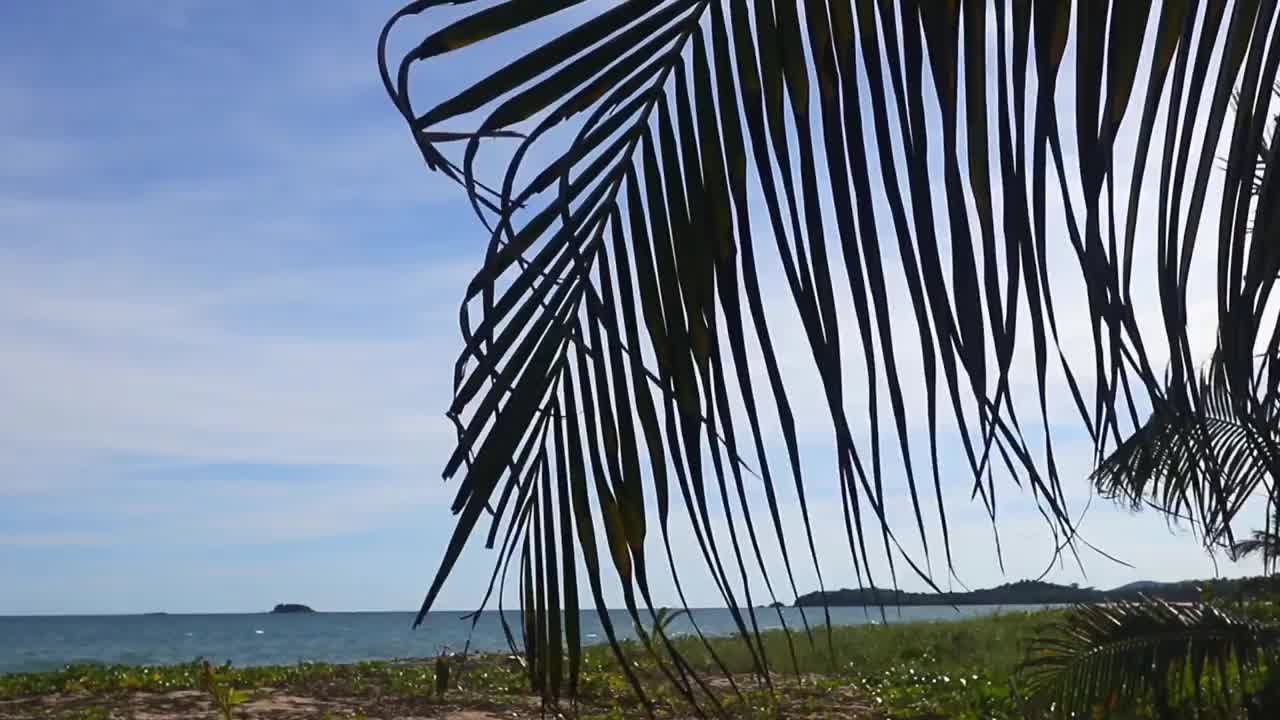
{"left": 0, "top": 253, "right": 465, "bottom": 476}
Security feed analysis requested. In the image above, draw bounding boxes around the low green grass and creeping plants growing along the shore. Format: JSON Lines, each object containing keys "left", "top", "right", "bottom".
{"left": 0, "top": 604, "right": 1051, "bottom": 720}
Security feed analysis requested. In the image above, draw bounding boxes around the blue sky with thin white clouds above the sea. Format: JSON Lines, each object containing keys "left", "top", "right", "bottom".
{"left": 0, "top": 0, "right": 1258, "bottom": 615}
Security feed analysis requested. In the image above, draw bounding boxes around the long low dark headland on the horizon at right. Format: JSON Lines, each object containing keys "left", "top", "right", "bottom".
{"left": 796, "top": 578, "right": 1258, "bottom": 607}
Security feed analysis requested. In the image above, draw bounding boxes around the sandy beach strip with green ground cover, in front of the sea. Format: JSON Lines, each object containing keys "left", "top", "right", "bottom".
{"left": 0, "top": 611, "right": 1052, "bottom": 720}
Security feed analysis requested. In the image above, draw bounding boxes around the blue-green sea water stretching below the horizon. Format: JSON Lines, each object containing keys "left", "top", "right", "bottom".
{"left": 0, "top": 605, "right": 1029, "bottom": 673}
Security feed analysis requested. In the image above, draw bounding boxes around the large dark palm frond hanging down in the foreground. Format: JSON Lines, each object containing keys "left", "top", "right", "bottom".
{"left": 379, "top": 0, "right": 1280, "bottom": 698}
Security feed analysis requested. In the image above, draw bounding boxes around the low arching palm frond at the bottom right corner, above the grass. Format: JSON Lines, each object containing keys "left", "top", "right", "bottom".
{"left": 1020, "top": 600, "right": 1280, "bottom": 717}
